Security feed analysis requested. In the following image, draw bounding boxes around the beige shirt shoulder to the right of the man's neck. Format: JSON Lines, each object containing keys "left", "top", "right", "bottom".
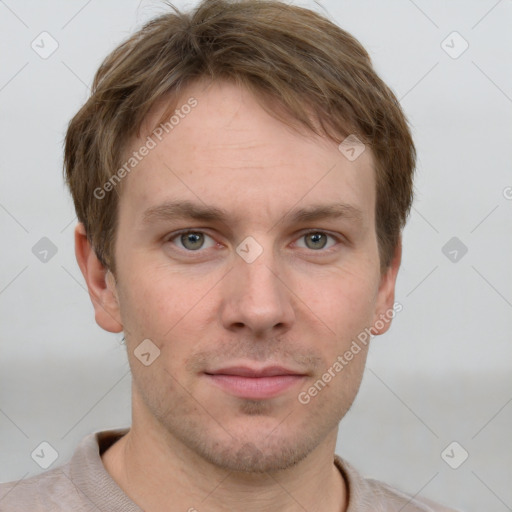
{"left": 335, "top": 455, "right": 457, "bottom": 512}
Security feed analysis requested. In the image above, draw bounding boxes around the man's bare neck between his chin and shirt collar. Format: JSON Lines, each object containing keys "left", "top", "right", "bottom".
{"left": 102, "top": 406, "right": 346, "bottom": 512}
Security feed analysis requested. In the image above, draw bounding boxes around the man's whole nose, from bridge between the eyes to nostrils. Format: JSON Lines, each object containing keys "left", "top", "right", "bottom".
{"left": 223, "top": 239, "right": 294, "bottom": 332}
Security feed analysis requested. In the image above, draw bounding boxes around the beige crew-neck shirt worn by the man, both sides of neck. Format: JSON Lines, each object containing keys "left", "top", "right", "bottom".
{"left": 0, "top": 429, "right": 456, "bottom": 512}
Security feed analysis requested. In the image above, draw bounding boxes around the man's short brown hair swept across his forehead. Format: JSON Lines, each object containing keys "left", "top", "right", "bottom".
{"left": 64, "top": 0, "right": 416, "bottom": 272}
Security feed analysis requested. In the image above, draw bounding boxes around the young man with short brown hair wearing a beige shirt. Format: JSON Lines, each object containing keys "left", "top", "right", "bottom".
{"left": 0, "top": 0, "right": 460, "bottom": 512}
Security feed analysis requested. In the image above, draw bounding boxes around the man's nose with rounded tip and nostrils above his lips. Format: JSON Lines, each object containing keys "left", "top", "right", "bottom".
{"left": 220, "top": 247, "right": 295, "bottom": 336}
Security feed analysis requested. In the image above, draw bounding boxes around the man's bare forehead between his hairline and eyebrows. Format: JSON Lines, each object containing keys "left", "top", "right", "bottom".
{"left": 121, "top": 82, "right": 375, "bottom": 228}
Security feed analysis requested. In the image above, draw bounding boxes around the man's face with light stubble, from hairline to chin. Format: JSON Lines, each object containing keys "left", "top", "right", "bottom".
{"left": 87, "top": 79, "right": 398, "bottom": 471}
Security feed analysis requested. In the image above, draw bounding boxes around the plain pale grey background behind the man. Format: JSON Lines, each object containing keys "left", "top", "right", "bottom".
{"left": 0, "top": 0, "right": 512, "bottom": 512}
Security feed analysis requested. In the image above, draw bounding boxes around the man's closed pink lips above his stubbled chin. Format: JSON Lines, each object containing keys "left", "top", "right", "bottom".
{"left": 204, "top": 366, "right": 307, "bottom": 400}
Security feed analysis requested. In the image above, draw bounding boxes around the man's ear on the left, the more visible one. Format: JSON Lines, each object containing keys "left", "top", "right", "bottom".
{"left": 75, "top": 223, "right": 123, "bottom": 332}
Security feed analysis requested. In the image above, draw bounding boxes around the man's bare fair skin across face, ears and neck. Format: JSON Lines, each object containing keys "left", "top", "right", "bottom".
{"left": 75, "top": 82, "right": 401, "bottom": 512}
